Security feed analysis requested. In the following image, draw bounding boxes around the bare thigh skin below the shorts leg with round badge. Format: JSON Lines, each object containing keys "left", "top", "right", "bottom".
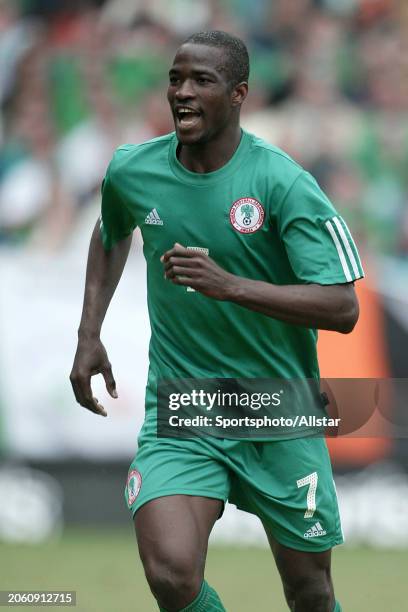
{"left": 134, "top": 495, "right": 223, "bottom": 579}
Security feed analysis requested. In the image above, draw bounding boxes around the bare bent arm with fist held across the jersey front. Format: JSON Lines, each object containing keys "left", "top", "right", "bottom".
{"left": 162, "top": 244, "right": 359, "bottom": 333}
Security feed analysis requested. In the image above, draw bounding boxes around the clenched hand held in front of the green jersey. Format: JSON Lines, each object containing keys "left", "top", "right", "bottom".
{"left": 160, "top": 242, "right": 238, "bottom": 300}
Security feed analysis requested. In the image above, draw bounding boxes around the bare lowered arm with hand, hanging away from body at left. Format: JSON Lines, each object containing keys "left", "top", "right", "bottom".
{"left": 70, "top": 221, "right": 132, "bottom": 416}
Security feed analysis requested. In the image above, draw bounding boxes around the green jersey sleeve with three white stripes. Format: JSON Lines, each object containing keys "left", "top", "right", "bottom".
{"left": 280, "top": 171, "right": 364, "bottom": 285}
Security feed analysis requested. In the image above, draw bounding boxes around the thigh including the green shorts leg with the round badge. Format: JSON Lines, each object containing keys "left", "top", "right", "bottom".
{"left": 125, "top": 423, "right": 229, "bottom": 577}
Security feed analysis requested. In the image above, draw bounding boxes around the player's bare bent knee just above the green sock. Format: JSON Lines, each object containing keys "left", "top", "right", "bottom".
{"left": 144, "top": 556, "right": 203, "bottom": 602}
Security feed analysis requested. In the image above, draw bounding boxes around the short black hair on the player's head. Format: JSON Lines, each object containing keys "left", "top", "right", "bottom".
{"left": 183, "top": 30, "right": 249, "bottom": 87}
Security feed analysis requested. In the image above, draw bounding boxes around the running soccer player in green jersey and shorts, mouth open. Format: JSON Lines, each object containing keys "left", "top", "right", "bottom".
{"left": 71, "top": 31, "right": 363, "bottom": 612}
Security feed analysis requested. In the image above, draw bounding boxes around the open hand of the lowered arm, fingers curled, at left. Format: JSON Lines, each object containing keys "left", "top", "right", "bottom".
{"left": 69, "top": 338, "right": 118, "bottom": 416}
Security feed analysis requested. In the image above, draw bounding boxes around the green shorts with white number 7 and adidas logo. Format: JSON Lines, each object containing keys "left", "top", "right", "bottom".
{"left": 125, "top": 419, "right": 343, "bottom": 552}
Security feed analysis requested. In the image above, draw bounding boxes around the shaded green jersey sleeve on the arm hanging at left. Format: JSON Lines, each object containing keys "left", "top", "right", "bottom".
{"left": 100, "top": 158, "right": 136, "bottom": 251}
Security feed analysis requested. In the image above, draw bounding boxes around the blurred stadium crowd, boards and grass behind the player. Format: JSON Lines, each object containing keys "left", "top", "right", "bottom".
{"left": 0, "top": 0, "right": 408, "bottom": 612}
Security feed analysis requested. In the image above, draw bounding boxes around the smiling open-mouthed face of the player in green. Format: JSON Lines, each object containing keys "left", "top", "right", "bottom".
{"left": 167, "top": 43, "right": 237, "bottom": 145}
